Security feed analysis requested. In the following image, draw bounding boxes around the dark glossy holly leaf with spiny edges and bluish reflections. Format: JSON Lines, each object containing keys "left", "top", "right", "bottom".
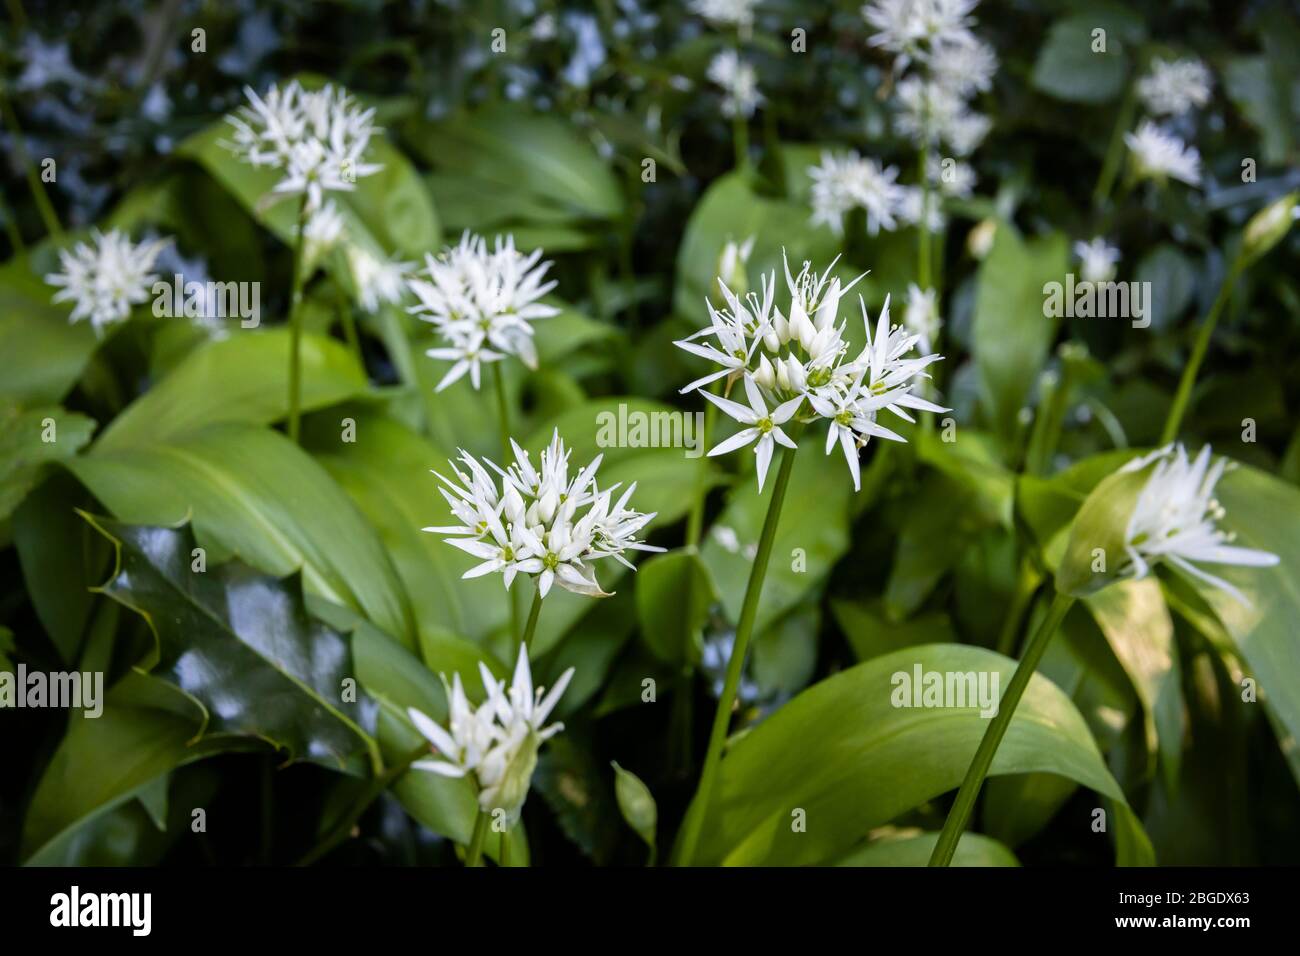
{"left": 86, "top": 515, "right": 378, "bottom": 771}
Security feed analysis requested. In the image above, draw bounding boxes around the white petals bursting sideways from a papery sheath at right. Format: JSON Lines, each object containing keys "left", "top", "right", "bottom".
{"left": 1121, "top": 444, "right": 1278, "bottom": 604}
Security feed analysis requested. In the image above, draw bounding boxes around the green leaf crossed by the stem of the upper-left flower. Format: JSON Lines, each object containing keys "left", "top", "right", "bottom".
{"left": 95, "top": 329, "right": 367, "bottom": 453}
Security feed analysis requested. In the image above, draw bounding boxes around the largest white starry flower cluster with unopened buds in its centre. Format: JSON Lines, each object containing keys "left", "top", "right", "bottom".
{"left": 676, "top": 252, "right": 946, "bottom": 490}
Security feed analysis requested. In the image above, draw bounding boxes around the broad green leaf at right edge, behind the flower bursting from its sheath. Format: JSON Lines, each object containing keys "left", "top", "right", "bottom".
{"left": 1192, "top": 466, "right": 1300, "bottom": 782}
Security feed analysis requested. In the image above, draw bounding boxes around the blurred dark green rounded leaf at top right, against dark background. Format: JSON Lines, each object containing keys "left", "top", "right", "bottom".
{"left": 1031, "top": 13, "right": 1127, "bottom": 103}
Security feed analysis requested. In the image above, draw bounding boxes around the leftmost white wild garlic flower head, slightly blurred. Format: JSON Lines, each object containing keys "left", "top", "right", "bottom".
{"left": 46, "top": 229, "right": 172, "bottom": 334}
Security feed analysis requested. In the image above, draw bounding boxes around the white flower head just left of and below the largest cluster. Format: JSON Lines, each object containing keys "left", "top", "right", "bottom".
{"left": 424, "top": 431, "right": 663, "bottom": 597}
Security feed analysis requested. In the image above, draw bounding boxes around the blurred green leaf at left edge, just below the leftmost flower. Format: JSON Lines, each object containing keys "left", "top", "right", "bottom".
{"left": 0, "top": 255, "right": 100, "bottom": 405}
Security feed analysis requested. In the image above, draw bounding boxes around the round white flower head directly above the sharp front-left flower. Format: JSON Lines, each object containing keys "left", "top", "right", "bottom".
{"left": 408, "top": 232, "right": 559, "bottom": 392}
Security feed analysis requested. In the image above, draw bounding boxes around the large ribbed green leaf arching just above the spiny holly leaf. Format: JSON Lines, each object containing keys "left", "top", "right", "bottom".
{"left": 69, "top": 424, "right": 415, "bottom": 646}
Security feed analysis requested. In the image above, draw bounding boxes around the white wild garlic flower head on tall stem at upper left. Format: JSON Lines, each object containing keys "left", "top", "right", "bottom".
{"left": 225, "top": 79, "right": 384, "bottom": 212}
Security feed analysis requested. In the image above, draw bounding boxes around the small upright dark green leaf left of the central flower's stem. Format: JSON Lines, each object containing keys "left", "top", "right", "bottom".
{"left": 636, "top": 550, "right": 718, "bottom": 665}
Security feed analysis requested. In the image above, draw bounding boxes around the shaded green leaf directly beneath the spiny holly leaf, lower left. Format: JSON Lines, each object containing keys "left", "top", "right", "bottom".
{"left": 22, "top": 672, "right": 264, "bottom": 864}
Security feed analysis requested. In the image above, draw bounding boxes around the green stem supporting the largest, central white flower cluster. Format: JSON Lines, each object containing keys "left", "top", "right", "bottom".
{"left": 677, "top": 424, "right": 803, "bottom": 866}
